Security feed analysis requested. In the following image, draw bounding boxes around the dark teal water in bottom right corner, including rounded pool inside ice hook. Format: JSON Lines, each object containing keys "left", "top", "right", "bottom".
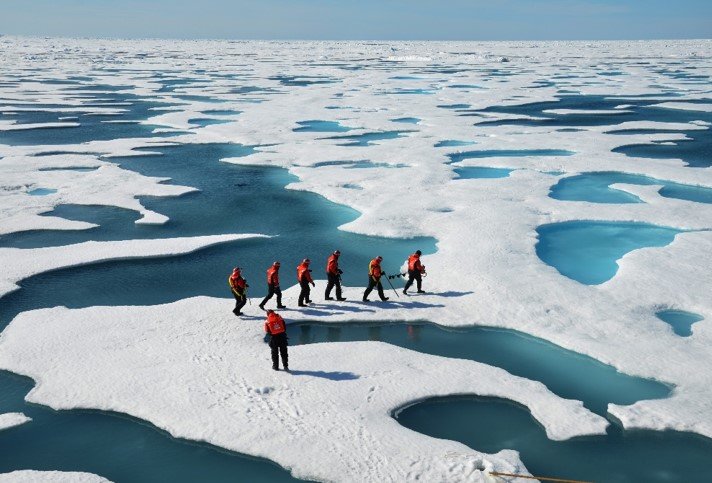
{"left": 396, "top": 397, "right": 712, "bottom": 483}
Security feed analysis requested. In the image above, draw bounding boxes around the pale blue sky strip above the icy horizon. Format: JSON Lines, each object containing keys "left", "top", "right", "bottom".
{"left": 0, "top": 0, "right": 712, "bottom": 40}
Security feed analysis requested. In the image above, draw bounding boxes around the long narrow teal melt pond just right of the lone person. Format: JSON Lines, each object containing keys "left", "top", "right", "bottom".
{"left": 290, "top": 322, "right": 670, "bottom": 415}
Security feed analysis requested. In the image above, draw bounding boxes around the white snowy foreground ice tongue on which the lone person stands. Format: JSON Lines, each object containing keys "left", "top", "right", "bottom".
{"left": 0, "top": 294, "right": 607, "bottom": 481}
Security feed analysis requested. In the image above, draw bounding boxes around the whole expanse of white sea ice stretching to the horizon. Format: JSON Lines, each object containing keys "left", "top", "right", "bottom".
{"left": 0, "top": 37, "right": 712, "bottom": 480}
